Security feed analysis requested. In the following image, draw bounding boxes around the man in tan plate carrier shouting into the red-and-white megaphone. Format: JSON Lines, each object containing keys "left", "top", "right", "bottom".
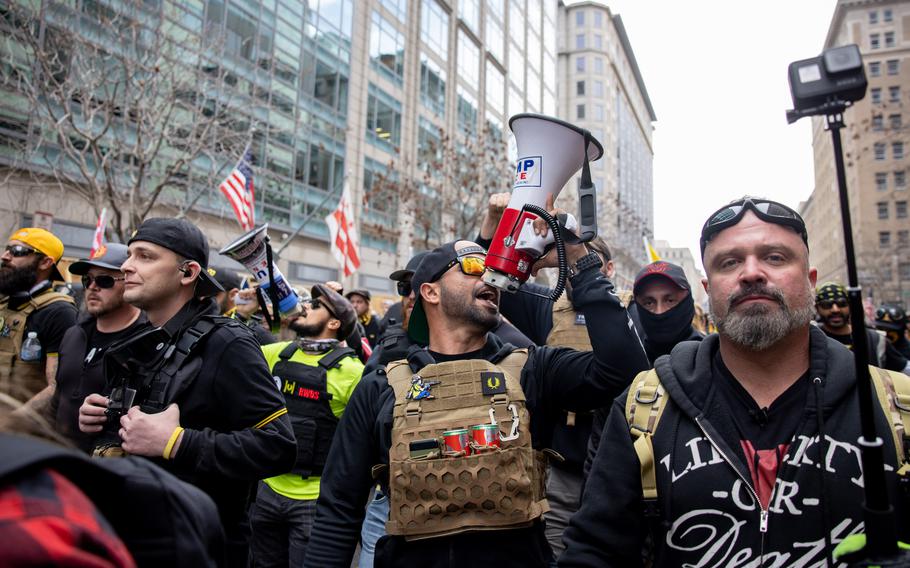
{"left": 305, "top": 236, "right": 647, "bottom": 567}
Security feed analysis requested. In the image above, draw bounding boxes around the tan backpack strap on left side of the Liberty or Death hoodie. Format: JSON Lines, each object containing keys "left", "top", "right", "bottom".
{"left": 626, "top": 369, "right": 667, "bottom": 516}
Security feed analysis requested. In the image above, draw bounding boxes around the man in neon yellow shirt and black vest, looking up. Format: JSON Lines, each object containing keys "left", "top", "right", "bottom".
{"left": 250, "top": 284, "right": 363, "bottom": 567}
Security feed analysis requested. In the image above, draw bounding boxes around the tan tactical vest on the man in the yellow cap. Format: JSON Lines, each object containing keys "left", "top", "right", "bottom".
{"left": 0, "top": 291, "right": 76, "bottom": 400}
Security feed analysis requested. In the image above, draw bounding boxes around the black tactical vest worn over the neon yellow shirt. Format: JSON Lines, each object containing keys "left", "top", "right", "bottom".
{"left": 272, "top": 341, "right": 357, "bottom": 478}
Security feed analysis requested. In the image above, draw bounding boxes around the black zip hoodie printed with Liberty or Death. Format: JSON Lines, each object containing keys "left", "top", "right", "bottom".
{"left": 559, "top": 327, "right": 907, "bottom": 568}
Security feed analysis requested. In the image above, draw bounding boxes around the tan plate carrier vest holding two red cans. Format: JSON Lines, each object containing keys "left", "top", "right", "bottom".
{"left": 386, "top": 349, "right": 549, "bottom": 539}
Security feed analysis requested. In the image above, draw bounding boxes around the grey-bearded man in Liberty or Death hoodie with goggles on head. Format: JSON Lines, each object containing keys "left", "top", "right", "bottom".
{"left": 559, "top": 198, "right": 908, "bottom": 567}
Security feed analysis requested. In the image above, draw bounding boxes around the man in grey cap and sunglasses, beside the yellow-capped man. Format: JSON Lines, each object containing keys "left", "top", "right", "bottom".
{"left": 49, "top": 243, "right": 148, "bottom": 453}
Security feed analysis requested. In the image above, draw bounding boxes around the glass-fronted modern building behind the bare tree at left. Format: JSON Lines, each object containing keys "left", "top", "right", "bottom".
{"left": 0, "top": 0, "right": 560, "bottom": 302}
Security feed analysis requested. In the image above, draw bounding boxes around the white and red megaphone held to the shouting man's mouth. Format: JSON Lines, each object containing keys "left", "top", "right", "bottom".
{"left": 483, "top": 114, "right": 603, "bottom": 299}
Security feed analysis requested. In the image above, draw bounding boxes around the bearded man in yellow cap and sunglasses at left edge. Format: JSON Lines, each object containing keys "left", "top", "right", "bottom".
{"left": 0, "top": 227, "right": 76, "bottom": 401}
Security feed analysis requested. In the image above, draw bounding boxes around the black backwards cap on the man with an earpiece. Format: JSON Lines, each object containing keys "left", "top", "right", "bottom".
{"left": 127, "top": 217, "right": 224, "bottom": 296}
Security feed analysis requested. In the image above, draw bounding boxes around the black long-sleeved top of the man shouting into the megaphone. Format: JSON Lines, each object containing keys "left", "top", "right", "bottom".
{"left": 304, "top": 269, "right": 648, "bottom": 568}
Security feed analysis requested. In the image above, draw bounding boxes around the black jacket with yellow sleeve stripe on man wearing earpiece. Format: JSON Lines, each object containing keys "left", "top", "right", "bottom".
{"left": 97, "top": 300, "right": 297, "bottom": 539}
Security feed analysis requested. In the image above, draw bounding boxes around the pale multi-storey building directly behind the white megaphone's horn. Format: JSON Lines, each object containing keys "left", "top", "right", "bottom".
{"left": 558, "top": 1, "right": 657, "bottom": 288}
